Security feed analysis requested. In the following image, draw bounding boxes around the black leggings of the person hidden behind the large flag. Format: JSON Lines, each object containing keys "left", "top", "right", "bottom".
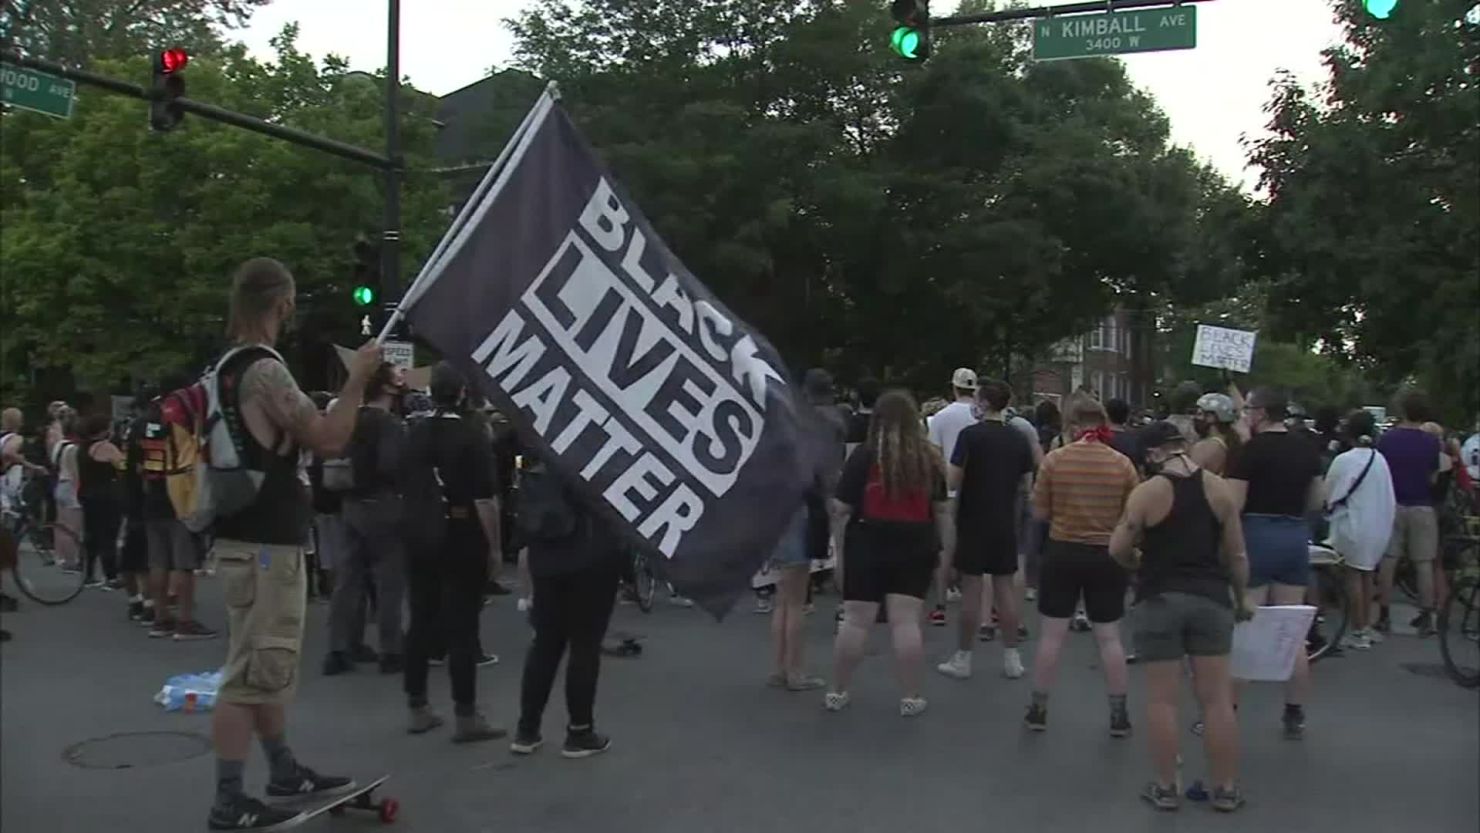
{"left": 519, "top": 562, "right": 620, "bottom": 734}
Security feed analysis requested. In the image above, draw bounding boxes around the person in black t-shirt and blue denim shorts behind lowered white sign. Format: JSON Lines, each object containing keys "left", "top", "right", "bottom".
{"left": 1228, "top": 388, "right": 1325, "bottom": 740}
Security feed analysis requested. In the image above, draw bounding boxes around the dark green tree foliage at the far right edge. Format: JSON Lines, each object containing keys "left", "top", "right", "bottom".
{"left": 1251, "top": 0, "right": 1480, "bottom": 417}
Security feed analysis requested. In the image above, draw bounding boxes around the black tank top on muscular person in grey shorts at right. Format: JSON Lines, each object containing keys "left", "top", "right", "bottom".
{"left": 1137, "top": 469, "right": 1233, "bottom": 607}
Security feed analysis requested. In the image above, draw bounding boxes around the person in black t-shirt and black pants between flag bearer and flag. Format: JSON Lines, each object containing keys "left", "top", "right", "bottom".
{"left": 401, "top": 362, "right": 508, "bottom": 743}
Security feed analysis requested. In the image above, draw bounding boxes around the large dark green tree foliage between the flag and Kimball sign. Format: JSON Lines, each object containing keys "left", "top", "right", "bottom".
{"left": 514, "top": 0, "right": 1248, "bottom": 382}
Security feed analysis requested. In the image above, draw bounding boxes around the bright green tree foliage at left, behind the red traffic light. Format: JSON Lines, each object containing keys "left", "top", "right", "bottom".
{"left": 0, "top": 27, "right": 447, "bottom": 401}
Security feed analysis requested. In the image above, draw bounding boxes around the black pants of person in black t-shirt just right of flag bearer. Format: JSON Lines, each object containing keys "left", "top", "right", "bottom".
{"left": 406, "top": 519, "right": 488, "bottom": 715}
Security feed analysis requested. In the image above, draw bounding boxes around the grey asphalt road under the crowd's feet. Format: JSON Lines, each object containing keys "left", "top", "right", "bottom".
{"left": 0, "top": 580, "right": 1480, "bottom": 833}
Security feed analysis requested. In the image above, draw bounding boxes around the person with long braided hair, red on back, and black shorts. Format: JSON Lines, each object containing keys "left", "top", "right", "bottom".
{"left": 824, "top": 391, "right": 952, "bottom": 718}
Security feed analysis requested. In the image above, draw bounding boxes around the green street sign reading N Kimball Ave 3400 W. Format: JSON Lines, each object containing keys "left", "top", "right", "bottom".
{"left": 1033, "top": 4, "right": 1197, "bottom": 61}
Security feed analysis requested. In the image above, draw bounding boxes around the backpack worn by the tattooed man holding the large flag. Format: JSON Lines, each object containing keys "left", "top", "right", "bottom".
{"left": 166, "top": 345, "right": 283, "bottom": 533}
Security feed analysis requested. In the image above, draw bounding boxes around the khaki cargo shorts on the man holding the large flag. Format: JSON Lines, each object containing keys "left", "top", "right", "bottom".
{"left": 216, "top": 539, "right": 308, "bottom": 706}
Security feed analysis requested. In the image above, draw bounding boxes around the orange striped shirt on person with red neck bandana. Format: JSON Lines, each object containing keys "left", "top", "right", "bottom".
{"left": 1033, "top": 439, "right": 1141, "bottom": 546}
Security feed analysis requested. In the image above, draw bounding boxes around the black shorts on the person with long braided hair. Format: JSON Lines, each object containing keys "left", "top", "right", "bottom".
{"left": 842, "top": 522, "right": 938, "bottom": 602}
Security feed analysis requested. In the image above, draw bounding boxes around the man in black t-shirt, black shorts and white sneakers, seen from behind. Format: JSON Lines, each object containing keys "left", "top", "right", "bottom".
{"left": 937, "top": 382, "right": 1036, "bottom": 679}
